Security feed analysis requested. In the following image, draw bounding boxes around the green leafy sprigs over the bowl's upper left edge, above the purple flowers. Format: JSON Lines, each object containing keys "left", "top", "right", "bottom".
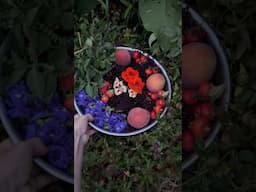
{"left": 75, "top": 13, "right": 126, "bottom": 96}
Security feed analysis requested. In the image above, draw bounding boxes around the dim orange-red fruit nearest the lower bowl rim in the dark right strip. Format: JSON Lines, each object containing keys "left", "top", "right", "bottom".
{"left": 191, "top": 117, "right": 209, "bottom": 137}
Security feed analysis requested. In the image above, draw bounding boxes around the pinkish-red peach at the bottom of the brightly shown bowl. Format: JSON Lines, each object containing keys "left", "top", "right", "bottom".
{"left": 127, "top": 107, "right": 150, "bottom": 129}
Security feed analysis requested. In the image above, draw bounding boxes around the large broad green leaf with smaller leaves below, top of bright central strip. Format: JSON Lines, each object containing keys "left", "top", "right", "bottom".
{"left": 139, "top": 0, "right": 181, "bottom": 57}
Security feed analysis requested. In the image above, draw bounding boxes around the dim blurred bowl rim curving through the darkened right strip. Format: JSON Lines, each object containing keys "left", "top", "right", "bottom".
{"left": 181, "top": 3, "right": 231, "bottom": 171}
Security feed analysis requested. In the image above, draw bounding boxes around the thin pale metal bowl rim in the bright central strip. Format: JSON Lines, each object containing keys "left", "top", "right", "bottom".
{"left": 74, "top": 46, "right": 173, "bottom": 137}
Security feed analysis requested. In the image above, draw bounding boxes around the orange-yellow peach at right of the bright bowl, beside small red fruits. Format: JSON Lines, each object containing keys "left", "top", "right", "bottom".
{"left": 146, "top": 73, "right": 165, "bottom": 92}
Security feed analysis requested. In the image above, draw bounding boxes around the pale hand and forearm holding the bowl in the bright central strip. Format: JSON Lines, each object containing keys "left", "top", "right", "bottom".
{"left": 74, "top": 115, "right": 96, "bottom": 192}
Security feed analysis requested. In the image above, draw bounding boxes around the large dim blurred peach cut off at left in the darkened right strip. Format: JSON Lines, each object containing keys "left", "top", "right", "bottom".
{"left": 182, "top": 43, "right": 217, "bottom": 88}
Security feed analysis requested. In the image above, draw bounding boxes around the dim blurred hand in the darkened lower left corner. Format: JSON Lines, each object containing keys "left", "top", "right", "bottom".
{"left": 0, "top": 138, "right": 56, "bottom": 192}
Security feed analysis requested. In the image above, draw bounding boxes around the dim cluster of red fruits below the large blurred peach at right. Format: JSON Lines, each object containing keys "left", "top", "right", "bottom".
{"left": 182, "top": 82, "right": 215, "bottom": 152}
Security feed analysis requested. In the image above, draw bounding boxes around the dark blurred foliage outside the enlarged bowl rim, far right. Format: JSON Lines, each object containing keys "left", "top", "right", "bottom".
{"left": 183, "top": 0, "right": 256, "bottom": 192}
